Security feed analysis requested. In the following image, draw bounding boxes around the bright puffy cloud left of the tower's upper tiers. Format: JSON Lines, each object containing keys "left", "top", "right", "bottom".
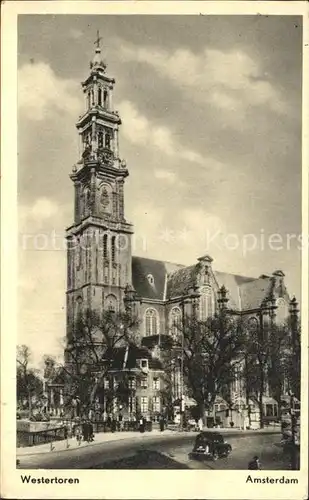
{"left": 18, "top": 62, "right": 81, "bottom": 121}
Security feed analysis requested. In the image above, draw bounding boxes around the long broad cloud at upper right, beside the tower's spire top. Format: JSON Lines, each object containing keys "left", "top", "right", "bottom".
{"left": 121, "top": 43, "right": 287, "bottom": 121}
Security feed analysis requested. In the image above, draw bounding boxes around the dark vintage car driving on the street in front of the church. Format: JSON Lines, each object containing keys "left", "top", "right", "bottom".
{"left": 189, "top": 431, "right": 232, "bottom": 460}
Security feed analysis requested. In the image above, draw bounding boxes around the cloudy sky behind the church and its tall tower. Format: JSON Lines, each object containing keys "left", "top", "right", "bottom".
{"left": 18, "top": 15, "right": 302, "bottom": 364}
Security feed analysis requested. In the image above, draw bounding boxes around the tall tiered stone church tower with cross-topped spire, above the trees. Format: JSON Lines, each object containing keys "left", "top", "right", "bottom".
{"left": 66, "top": 34, "right": 133, "bottom": 335}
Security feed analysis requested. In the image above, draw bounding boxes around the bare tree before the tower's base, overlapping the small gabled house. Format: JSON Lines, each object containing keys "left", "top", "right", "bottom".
{"left": 51, "top": 309, "right": 138, "bottom": 412}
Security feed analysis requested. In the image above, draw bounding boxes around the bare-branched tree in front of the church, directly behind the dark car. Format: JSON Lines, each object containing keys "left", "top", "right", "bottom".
{"left": 171, "top": 308, "right": 245, "bottom": 417}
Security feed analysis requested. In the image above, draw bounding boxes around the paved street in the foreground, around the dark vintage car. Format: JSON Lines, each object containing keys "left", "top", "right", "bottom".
{"left": 19, "top": 431, "right": 289, "bottom": 470}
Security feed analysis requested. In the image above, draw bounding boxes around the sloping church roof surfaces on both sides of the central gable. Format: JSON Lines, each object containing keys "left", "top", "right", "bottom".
{"left": 132, "top": 257, "right": 272, "bottom": 311}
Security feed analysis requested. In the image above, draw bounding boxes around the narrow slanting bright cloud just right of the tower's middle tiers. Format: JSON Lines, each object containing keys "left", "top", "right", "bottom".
{"left": 118, "top": 101, "right": 204, "bottom": 165}
